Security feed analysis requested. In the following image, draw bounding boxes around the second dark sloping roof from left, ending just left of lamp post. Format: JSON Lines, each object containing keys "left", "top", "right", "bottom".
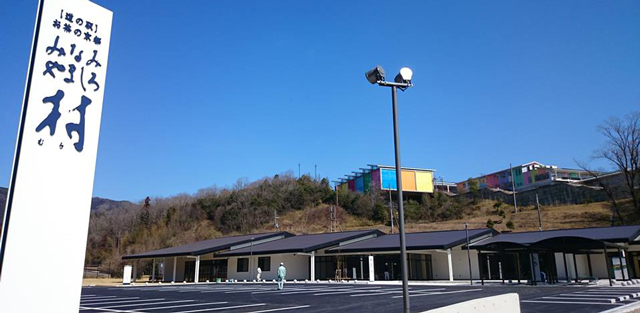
{"left": 219, "top": 230, "right": 384, "bottom": 256}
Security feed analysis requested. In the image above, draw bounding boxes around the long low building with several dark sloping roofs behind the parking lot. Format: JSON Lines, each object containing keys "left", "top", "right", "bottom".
{"left": 123, "top": 225, "right": 640, "bottom": 284}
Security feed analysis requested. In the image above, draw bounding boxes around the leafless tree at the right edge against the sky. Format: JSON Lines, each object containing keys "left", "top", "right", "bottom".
{"left": 594, "top": 112, "right": 640, "bottom": 212}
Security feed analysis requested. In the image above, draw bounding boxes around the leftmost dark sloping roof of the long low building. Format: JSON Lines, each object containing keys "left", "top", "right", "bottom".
{"left": 122, "top": 232, "right": 293, "bottom": 260}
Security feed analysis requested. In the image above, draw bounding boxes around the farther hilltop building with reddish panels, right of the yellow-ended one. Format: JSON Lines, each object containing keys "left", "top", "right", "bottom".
{"left": 457, "top": 161, "right": 593, "bottom": 193}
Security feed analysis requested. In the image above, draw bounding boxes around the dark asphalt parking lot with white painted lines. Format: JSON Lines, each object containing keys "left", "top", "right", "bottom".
{"left": 80, "top": 283, "right": 640, "bottom": 313}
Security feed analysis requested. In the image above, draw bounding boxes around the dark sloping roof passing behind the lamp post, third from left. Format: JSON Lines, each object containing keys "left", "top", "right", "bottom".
{"left": 327, "top": 229, "right": 495, "bottom": 253}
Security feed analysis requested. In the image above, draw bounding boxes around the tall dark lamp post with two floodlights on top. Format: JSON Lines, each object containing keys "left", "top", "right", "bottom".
{"left": 365, "top": 66, "right": 413, "bottom": 313}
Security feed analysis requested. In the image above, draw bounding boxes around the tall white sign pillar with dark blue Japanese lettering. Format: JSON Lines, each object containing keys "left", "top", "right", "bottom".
{"left": 0, "top": 0, "right": 112, "bottom": 312}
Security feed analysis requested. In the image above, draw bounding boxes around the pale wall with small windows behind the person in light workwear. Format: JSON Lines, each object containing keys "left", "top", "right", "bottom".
{"left": 227, "top": 254, "right": 311, "bottom": 281}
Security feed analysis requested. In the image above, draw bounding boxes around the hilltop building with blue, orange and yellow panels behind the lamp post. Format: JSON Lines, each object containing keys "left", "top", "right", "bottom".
{"left": 336, "top": 164, "right": 434, "bottom": 193}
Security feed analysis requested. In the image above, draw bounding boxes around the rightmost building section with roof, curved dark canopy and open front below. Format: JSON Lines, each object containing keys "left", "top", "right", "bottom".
{"left": 471, "top": 226, "right": 640, "bottom": 285}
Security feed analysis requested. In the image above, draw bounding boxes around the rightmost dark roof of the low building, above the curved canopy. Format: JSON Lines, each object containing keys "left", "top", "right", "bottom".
{"left": 471, "top": 225, "right": 640, "bottom": 249}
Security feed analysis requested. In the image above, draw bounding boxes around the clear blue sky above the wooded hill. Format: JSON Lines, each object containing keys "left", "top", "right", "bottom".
{"left": 0, "top": 0, "right": 640, "bottom": 201}
